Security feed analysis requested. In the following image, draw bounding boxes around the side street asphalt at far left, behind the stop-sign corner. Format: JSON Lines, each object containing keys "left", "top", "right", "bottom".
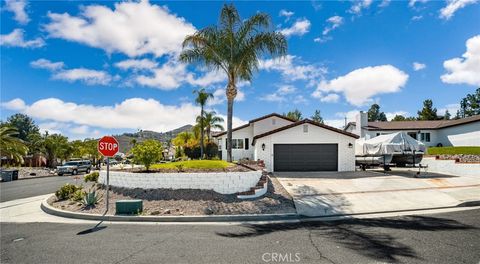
{"left": 0, "top": 175, "right": 78, "bottom": 202}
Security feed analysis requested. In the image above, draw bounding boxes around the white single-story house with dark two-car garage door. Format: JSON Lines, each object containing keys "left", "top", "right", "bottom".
{"left": 214, "top": 113, "right": 358, "bottom": 171}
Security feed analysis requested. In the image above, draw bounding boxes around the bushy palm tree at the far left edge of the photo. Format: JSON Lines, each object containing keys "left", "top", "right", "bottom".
{"left": 0, "top": 126, "right": 28, "bottom": 163}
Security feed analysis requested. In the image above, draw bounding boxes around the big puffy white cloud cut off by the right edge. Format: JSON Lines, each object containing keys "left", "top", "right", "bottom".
{"left": 440, "top": 35, "right": 480, "bottom": 86}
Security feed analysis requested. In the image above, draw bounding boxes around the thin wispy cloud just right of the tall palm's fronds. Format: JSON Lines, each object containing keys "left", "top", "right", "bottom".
{"left": 259, "top": 55, "right": 327, "bottom": 81}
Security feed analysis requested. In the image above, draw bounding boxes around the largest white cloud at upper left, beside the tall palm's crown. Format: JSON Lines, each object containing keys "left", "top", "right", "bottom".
{"left": 45, "top": 1, "right": 195, "bottom": 57}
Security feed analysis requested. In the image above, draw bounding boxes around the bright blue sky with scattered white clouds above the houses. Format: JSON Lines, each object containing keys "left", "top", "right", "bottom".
{"left": 0, "top": 0, "right": 480, "bottom": 138}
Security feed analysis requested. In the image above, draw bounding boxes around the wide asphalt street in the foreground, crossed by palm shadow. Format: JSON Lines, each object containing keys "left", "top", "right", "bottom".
{"left": 0, "top": 210, "right": 480, "bottom": 264}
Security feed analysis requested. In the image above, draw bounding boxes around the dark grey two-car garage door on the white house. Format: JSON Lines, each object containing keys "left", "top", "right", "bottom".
{"left": 273, "top": 144, "right": 338, "bottom": 171}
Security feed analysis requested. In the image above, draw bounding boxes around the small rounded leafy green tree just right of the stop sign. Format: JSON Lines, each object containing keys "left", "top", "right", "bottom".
{"left": 131, "top": 139, "right": 162, "bottom": 171}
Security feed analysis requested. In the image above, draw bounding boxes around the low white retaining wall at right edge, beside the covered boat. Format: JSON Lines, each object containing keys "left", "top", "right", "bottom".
{"left": 421, "top": 157, "right": 480, "bottom": 177}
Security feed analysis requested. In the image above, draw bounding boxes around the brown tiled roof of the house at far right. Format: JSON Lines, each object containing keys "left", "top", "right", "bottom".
{"left": 345, "top": 115, "right": 480, "bottom": 130}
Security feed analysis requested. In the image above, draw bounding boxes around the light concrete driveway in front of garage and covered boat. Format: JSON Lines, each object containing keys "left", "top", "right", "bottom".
{"left": 274, "top": 169, "right": 480, "bottom": 216}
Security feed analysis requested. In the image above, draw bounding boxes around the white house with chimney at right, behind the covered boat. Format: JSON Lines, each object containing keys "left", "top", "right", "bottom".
{"left": 344, "top": 112, "right": 480, "bottom": 147}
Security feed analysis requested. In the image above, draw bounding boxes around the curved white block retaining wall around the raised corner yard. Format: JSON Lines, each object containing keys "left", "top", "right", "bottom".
{"left": 98, "top": 171, "right": 262, "bottom": 194}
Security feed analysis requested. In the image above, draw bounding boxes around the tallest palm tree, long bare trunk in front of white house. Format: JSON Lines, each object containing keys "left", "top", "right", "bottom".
{"left": 180, "top": 4, "right": 287, "bottom": 161}
